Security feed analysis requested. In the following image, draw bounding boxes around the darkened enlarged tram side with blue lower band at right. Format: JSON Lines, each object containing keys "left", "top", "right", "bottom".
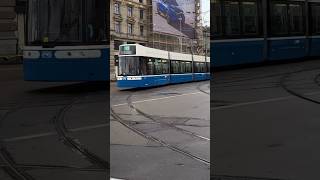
{"left": 211, "top": 0, "right": 320, "bottom": 67}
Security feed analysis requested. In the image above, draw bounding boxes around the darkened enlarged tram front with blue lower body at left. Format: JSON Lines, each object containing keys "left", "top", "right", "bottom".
{"left": 23, "top": 0, "right": 110, "bottom": 81}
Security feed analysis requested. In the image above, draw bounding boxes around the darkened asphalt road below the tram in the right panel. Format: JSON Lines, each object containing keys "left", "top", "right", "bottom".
{"left": 211, "top": 60, "right": 320, "bottom": 180}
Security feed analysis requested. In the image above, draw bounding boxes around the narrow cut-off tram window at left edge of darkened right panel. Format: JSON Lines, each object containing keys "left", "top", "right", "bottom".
{"left": 211, "top": 0, "right": 222, "bottom": 36}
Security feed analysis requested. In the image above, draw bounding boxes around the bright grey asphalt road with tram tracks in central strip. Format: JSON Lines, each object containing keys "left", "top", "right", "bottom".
{"left": 110, "top": 81, "right": 210, "bottom": 180}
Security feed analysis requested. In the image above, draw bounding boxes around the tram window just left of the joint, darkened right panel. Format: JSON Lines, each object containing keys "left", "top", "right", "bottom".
{"left": 241, "top": 2, "right": 258, "bottom": 34}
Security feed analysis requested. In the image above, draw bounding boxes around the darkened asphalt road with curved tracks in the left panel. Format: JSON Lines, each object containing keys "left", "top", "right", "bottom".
{"left": 0, "top": 65, "right": 110, "bottom": 180}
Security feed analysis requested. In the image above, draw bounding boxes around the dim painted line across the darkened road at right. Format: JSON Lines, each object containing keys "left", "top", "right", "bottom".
{"left": 212, "top": 92, "right": 320, "bottom": 111}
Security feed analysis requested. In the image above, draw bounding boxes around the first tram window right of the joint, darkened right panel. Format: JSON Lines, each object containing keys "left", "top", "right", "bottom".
{"left": 270, "top": 3, "right": 288, "bottom": 35}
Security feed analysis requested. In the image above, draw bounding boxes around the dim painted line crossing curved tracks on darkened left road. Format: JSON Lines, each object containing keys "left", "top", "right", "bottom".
{"left": 3, "top": 123, "right": 109, "bottom": 142}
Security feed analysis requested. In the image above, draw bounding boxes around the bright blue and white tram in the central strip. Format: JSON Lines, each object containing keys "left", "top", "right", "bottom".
{"left": 117, "top": 44, "right": 210, "bottom": 89}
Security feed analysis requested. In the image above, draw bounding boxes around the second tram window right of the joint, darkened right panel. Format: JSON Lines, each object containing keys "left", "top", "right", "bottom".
{"left": 288, "top": 4, "right": 304, "bottom": 34}
